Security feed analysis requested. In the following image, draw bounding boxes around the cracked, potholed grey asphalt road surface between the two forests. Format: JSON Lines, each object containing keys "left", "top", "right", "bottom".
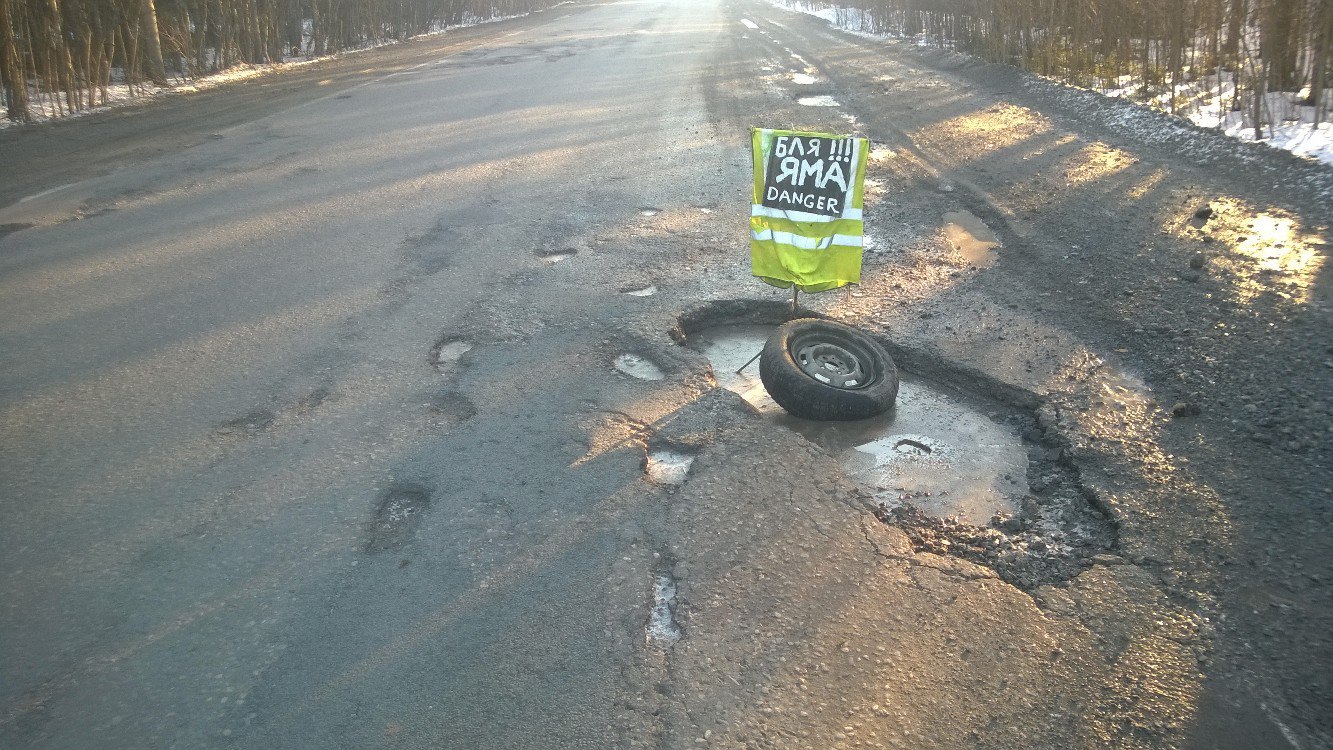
{"left": 0, "top": 0, "right": 1333, "bottom": 749}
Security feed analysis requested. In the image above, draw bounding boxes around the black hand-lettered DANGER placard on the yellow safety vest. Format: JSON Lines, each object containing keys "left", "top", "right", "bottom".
{"left": 762, "top": 136, "right": 854, "bottom": 216}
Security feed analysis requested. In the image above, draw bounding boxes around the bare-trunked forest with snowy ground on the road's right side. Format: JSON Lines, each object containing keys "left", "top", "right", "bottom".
{"left": 840, "top": 0, "right": 1333, "bottom": 139}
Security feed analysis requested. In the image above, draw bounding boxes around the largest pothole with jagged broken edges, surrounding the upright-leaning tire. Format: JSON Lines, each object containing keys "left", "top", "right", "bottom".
{"left": 680, "top": 304, "right": 1116, "bottom": 590}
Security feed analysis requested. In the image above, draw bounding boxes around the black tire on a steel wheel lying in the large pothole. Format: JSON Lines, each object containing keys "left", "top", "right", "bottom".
{"left": 758, "top": 318, "right": 898, "bottom": 421}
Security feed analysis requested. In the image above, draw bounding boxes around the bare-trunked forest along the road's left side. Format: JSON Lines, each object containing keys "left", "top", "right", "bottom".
{"left": 0, "top": 0, "right": 556, "bottom": 123}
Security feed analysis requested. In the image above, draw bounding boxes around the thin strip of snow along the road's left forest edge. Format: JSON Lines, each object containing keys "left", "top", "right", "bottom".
{"left": 0, "top": 8, "right": 541, "bottom": 129}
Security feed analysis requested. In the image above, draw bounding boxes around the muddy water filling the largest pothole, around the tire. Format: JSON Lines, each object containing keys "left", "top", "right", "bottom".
{"left": 690, "top": 325, "right": 1029, "bottom": 526}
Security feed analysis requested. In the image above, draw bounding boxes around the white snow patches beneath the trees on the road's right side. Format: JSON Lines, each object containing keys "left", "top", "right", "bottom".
{"left": 768, "top": 0, "right": 1333, "bottom": 165}
